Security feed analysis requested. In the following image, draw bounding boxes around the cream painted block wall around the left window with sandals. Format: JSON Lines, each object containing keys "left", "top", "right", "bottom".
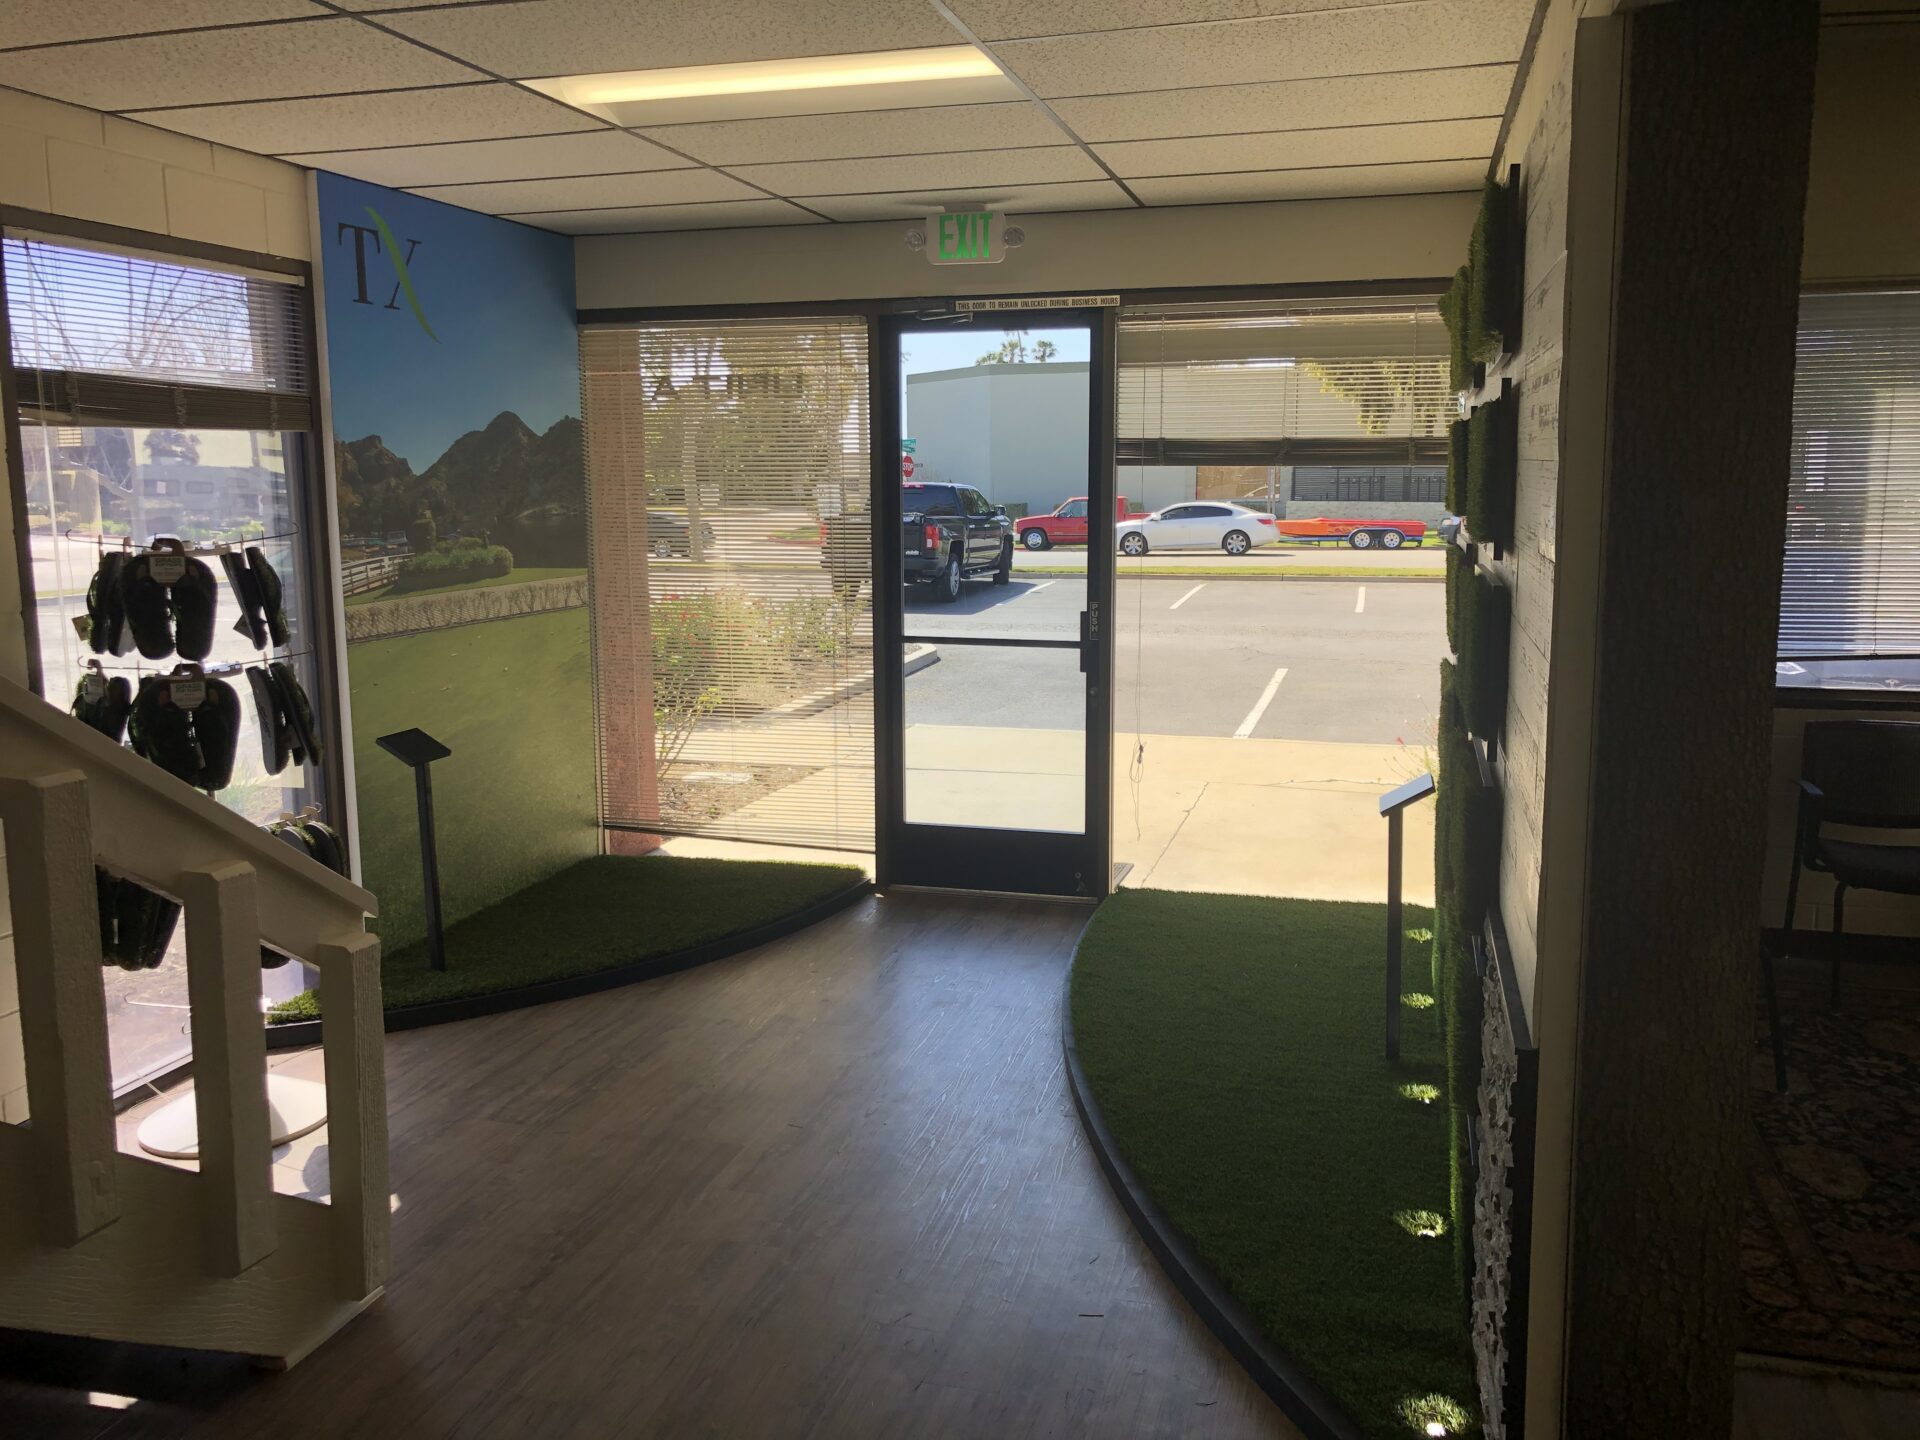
{"left": 0, "top": 88, "right": 309, "bottom": 1121}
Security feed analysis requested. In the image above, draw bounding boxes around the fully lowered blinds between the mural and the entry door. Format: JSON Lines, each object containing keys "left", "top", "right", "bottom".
{"left": 580, "top": 319, "right": 874, "bottom": 851}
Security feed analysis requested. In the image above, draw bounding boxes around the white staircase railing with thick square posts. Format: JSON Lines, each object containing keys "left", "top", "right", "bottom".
{"left": 0, "top": 680, "right": 390, "bottom": 1365}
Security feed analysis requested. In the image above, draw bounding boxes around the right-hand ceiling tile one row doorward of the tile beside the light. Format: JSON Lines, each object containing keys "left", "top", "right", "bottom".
{"left": 1052, "top": 65, "right": 1515, "bottom": 142}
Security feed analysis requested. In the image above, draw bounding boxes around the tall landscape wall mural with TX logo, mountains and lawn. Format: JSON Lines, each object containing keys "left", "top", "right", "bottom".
{"left": 319, "top": 173, "right": 595, "bottom": 950}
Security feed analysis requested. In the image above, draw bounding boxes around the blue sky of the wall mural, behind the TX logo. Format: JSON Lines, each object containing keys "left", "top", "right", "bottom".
{"left": 319, "top": 171, "right": 580, "bottom": 472}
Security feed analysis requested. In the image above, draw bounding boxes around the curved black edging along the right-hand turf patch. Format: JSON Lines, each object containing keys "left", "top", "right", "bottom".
{"left": 1060, "top": 971, "right": 1363, "bottom": 1440}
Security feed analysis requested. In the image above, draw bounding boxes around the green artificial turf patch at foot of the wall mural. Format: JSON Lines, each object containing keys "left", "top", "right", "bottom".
{"left": 269, "top": 854, "right": 864, "bottom": 1025}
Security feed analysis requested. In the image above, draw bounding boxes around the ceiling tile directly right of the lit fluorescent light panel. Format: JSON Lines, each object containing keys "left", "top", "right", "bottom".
{"left": 995, "top": 0, "right": 1532, "bottom": 96}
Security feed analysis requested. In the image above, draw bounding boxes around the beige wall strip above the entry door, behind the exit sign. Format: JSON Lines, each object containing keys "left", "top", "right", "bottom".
{"left": 574, "top": 194, "right": 1476, "bottom": 309}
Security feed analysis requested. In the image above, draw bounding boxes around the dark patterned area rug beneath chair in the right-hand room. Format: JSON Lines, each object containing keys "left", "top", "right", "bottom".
{"left": 1741, "top": 975, "right": 1920, "bottom": 1375}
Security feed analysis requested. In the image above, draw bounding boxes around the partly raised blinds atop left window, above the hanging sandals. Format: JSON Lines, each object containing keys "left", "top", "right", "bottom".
{"left": 4, "top": 234, "right": 313, "bottom": 430}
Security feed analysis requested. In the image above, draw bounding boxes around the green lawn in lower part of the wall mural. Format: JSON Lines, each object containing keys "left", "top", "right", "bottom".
{"left": 348, "top": 609, "right": 595, "bottom": 947}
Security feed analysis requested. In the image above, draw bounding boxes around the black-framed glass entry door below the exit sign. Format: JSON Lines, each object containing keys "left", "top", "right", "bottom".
{"left": 874, "top": 309, "right": 1114, "bottom": 899}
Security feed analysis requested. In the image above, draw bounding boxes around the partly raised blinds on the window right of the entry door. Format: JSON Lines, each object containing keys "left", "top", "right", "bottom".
{"left": 1119, "top": 300, "right": 1455, "bottom": 465}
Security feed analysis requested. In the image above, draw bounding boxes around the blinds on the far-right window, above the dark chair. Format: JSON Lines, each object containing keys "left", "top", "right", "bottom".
{"left": 1780, "top": 290, "right": 1920, "bottom": 659}
